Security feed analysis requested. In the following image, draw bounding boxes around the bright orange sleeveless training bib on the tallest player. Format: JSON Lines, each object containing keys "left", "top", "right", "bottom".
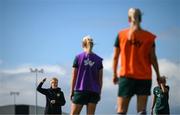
{"left": 118, "top": 29, "right": 156, "bottom": 80}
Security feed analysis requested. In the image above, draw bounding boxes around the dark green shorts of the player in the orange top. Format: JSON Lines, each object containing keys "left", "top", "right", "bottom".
{"left": 118, "top": 77, "right": 152, "bottom": 97}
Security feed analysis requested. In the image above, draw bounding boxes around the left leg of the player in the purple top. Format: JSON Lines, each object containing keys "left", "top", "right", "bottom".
{"left": 70, "top": 103, "right": 83, "bottom": 115}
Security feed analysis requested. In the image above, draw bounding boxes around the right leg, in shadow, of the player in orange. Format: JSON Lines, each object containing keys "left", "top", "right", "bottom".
{"left": 137, "top": 95, "right": 148, "bottom": 115}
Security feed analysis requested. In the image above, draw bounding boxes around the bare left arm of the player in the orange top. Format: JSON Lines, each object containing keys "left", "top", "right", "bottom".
{"left": 112, "top": 47, "right": 120, "bottom": 84}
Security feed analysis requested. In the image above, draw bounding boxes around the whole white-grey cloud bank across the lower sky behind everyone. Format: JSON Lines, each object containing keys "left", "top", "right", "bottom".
{"left": 0, "top": 58, "right": 180, "bottom": 114}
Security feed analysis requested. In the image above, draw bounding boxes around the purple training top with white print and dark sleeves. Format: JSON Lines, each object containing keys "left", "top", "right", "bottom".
{"left": 73, "top": 52, "right": 103, "bottom": 93}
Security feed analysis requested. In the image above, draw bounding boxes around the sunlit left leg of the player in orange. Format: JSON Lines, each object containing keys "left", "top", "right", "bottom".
{"left": 117, "top": 97, "right": 131, "bottom": 114}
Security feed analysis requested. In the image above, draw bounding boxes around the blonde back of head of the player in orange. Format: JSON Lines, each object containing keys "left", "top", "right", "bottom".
{"left": 128, "top": 8, "right": 142, "bottom": 23}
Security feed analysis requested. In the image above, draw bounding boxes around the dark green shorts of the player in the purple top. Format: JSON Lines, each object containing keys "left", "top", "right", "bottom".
{"left": 72, "top": 91, "right": 100, "bottom": 105}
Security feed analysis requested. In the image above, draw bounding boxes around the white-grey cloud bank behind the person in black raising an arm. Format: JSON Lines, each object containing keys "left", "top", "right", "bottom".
{"left": 0, "top": 65, "right": 69, "bottom": 106}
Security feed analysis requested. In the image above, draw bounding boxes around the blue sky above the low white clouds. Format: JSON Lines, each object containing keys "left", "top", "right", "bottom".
{"left": 0, "top": 0, "right": 180, "bottom": 111}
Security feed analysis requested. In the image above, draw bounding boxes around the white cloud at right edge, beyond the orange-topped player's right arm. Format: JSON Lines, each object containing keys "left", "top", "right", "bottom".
{"left": 159, "top": 59, "right": 180, "bottom": 112}
